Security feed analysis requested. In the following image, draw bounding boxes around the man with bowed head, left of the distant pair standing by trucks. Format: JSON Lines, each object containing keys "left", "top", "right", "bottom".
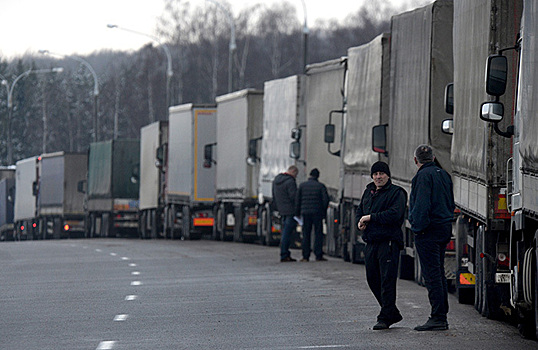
{"left": 272, "top": 165, "right": 299, "bottom": 262}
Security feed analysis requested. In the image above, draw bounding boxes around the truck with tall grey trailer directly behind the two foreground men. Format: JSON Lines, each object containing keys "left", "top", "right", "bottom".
{"left": 373, "top": 0, "right": 456, "bottom": 284}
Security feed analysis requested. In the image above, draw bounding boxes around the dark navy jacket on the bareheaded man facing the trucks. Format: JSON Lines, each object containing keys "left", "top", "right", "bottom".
{"left": 409, "top": 162, "right": 455, "bottom": 233}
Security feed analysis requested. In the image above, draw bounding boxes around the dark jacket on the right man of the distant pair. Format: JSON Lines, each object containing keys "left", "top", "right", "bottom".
{"left": 296, "top": 177, "right": 329, "bottom": 217}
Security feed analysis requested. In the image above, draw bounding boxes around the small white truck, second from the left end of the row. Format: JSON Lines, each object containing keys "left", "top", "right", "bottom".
{"left": 13, "top": 156, "right": 38, "bottom": 240}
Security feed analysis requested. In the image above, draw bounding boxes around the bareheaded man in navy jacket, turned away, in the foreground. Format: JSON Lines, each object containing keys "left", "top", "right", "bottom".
{"left": 409, "top": 145, "right": 455, "bottom": 331}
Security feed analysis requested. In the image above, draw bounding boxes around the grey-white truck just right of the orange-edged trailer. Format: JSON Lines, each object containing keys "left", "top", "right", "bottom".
{"left": 209, "top": 89, "right": 263, "bottom": 242}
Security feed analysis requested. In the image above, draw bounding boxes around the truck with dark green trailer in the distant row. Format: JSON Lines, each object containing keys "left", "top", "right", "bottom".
{"left": 84, "top": 139, "right": 140, "bottom": 237}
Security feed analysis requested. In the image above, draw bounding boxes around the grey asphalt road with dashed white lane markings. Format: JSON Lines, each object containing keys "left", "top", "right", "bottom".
{"left": 0, "top": 239, "right": 538, "bottom": 350}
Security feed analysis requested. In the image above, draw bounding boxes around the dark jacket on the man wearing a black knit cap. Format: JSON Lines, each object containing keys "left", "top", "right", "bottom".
{"left": 355, "top": 179, "right": 407, "bottom": 247}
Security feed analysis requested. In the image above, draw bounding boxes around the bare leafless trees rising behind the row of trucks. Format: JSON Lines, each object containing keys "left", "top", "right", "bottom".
{"left": 0, "top": 0, "right": 427, "bottom": 165}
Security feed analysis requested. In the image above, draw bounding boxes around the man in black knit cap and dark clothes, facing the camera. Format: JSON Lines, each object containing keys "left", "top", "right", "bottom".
{"left": 355, "top": 162, "right": 407, "bottom": 330}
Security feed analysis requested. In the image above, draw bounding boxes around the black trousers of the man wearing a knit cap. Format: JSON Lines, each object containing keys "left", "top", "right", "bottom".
{"left": 364, "top": 241, "right": 400, "bottom": 322}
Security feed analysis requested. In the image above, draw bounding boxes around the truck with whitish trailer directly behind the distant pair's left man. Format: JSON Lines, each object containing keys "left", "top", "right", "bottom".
{"left": 253, "top": 75, "right": 306, "bottom": 245}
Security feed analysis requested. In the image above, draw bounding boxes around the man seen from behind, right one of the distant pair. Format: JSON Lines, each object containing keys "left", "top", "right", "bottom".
{"left": 296, "top": 168, "right": 329, "bottom": 262}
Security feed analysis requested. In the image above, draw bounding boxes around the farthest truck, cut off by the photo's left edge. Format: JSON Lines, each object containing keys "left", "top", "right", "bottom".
{"left": 0, "top": 166, "right": 15, "bottom": 241}
